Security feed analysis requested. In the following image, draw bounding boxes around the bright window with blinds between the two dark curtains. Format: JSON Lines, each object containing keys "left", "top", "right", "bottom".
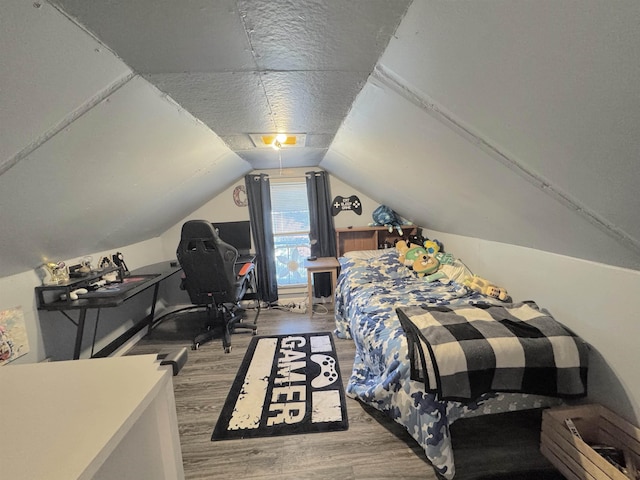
{"left": 271, "top": 181, "right": 311, "bottom": 287}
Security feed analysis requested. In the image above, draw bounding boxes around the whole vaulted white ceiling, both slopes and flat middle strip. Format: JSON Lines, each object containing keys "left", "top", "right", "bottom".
{"left": 0, "top": 0, "right": 640, "bottom": 276}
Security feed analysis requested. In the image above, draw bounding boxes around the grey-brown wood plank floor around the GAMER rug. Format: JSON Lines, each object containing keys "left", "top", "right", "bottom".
{"left": 129, "top": 309, "right": 563, "bottom": 480}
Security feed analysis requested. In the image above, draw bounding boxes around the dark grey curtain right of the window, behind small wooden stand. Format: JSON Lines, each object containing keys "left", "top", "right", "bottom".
{"left": 305, "top": 172, "right": 337, "bottom": 298}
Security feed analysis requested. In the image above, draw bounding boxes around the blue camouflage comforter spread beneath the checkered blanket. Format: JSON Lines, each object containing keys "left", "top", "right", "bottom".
{"left": 335, "top": 249, "right": 555, "bottom": 479}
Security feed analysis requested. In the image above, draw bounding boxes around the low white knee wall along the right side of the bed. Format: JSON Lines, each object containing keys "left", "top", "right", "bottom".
{"left": 425, "top": 231, "right": 640, "bottom": 425}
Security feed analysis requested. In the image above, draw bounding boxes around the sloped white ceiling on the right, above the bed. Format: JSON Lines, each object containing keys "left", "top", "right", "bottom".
{"left": 321, "top": 0, "right": 640, "bottom": 269}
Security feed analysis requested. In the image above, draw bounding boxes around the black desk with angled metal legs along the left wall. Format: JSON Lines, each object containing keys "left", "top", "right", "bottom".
{"left": 36, "top": 261, "right": 182, "bottom": 360}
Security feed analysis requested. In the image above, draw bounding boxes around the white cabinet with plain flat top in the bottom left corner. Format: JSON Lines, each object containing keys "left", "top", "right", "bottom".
{"left": 0, "top": 355, "right": 184, "bottom": 480}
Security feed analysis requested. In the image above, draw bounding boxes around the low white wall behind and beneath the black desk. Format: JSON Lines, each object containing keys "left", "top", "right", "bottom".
{"left": 0, "top": 238, "right": 165, "bottom": 364}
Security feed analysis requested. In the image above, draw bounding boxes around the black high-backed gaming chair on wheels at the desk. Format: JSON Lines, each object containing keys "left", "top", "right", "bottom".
{"left": 176, "top": 220, "right": 260, "bottom": 353}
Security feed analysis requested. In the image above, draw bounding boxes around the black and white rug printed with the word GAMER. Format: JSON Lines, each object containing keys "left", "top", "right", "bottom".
{"left": 211, "top": 332, "right": 349, "bottom": 440}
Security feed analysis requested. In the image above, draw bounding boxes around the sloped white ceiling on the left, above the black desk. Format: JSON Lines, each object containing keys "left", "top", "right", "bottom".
{"left": 0, "top": 1, "right": 251, "bottom": 276}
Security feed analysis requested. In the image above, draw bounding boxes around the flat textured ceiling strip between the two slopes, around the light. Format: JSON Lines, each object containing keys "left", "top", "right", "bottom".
{"left": 53, "top": 0, "right": 410, "bottom": 169}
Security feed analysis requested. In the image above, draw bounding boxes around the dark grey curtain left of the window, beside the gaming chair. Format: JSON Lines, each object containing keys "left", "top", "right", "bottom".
{"left": 244, "top": 174, "right": 278, "bottom": 304}
